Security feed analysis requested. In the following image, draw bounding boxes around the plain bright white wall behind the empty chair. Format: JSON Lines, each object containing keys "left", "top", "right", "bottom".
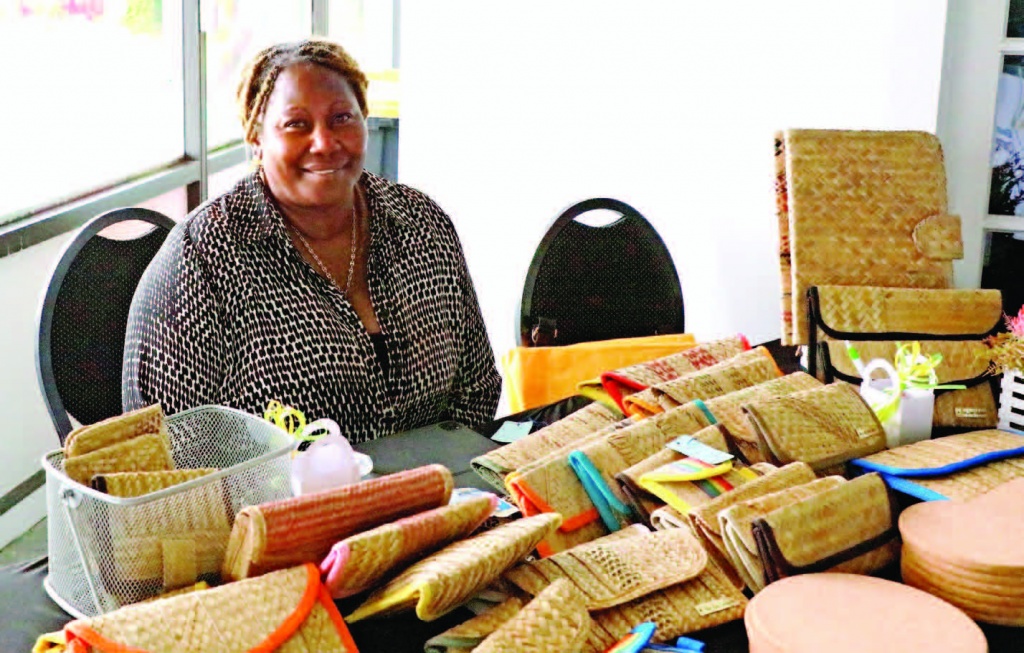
{"left": 399, "top": 0, "right": 946, "bottom": 355}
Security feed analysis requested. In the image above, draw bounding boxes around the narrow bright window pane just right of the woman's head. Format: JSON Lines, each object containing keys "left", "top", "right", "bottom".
{"left": 328, "top": 0, "right": 398, "bottom": 118}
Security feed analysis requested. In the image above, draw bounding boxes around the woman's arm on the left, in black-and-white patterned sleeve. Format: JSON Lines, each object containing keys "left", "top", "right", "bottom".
{"left": 122, "top": 222, "right": 224, "bottom": 415}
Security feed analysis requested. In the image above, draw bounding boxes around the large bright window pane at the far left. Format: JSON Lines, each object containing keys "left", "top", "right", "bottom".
{"left": 0, "top": 0, "right": 184, "bottom": 222}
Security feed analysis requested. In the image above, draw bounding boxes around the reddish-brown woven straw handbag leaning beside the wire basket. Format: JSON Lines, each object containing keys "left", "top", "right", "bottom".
{"left": 221, "top": 465, "right": 454, "bottom": 580}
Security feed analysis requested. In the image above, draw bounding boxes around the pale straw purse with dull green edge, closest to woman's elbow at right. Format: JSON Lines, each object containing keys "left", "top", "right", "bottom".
{"left": 471, "top": 402, "right": 629, "bottom": 492}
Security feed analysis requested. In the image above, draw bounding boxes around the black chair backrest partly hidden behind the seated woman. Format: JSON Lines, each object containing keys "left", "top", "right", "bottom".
{"left": 36, "top": 209, "right": 175, "bottom": 444}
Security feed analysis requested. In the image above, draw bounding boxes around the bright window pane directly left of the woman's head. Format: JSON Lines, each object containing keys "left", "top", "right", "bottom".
{"left": 201, "top": 0, "right": 312, "bottom": 149}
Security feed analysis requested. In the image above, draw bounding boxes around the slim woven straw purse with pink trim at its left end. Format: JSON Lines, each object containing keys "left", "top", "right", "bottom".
{"left": 321, "top": 494, "right": 498, "bottom": 599}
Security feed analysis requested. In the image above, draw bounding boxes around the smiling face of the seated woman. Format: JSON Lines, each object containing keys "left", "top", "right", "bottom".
{"left": 255, "top": 63, "right": 367, "bottom": 209}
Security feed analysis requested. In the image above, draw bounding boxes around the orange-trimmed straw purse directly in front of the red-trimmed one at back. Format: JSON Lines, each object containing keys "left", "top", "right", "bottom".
{"left": 623, "top": 347, "right": 782, "bottom": 420}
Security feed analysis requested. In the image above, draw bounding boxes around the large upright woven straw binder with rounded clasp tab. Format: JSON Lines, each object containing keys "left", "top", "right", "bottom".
{"left": 775, "top": 129, "right": 963, "bottom": 345}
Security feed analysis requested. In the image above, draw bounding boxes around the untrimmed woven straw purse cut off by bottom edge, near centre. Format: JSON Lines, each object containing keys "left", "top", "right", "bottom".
{"left": 474, "top": 580, "right": 593, "bottom": 653}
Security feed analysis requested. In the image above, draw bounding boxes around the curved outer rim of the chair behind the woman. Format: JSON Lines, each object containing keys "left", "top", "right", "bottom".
{"left": 36, "top": 208, "right": 177, "bottom": 445}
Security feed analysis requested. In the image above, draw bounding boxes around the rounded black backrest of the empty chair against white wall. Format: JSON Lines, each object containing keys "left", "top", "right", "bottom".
{"left": 516, "top": 198, "right": 684, "bottom": 347}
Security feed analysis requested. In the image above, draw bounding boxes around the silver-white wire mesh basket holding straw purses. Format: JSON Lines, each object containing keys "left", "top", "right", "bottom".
{"left": 43, "top": 406, "right": 295, "bottom": 618}
